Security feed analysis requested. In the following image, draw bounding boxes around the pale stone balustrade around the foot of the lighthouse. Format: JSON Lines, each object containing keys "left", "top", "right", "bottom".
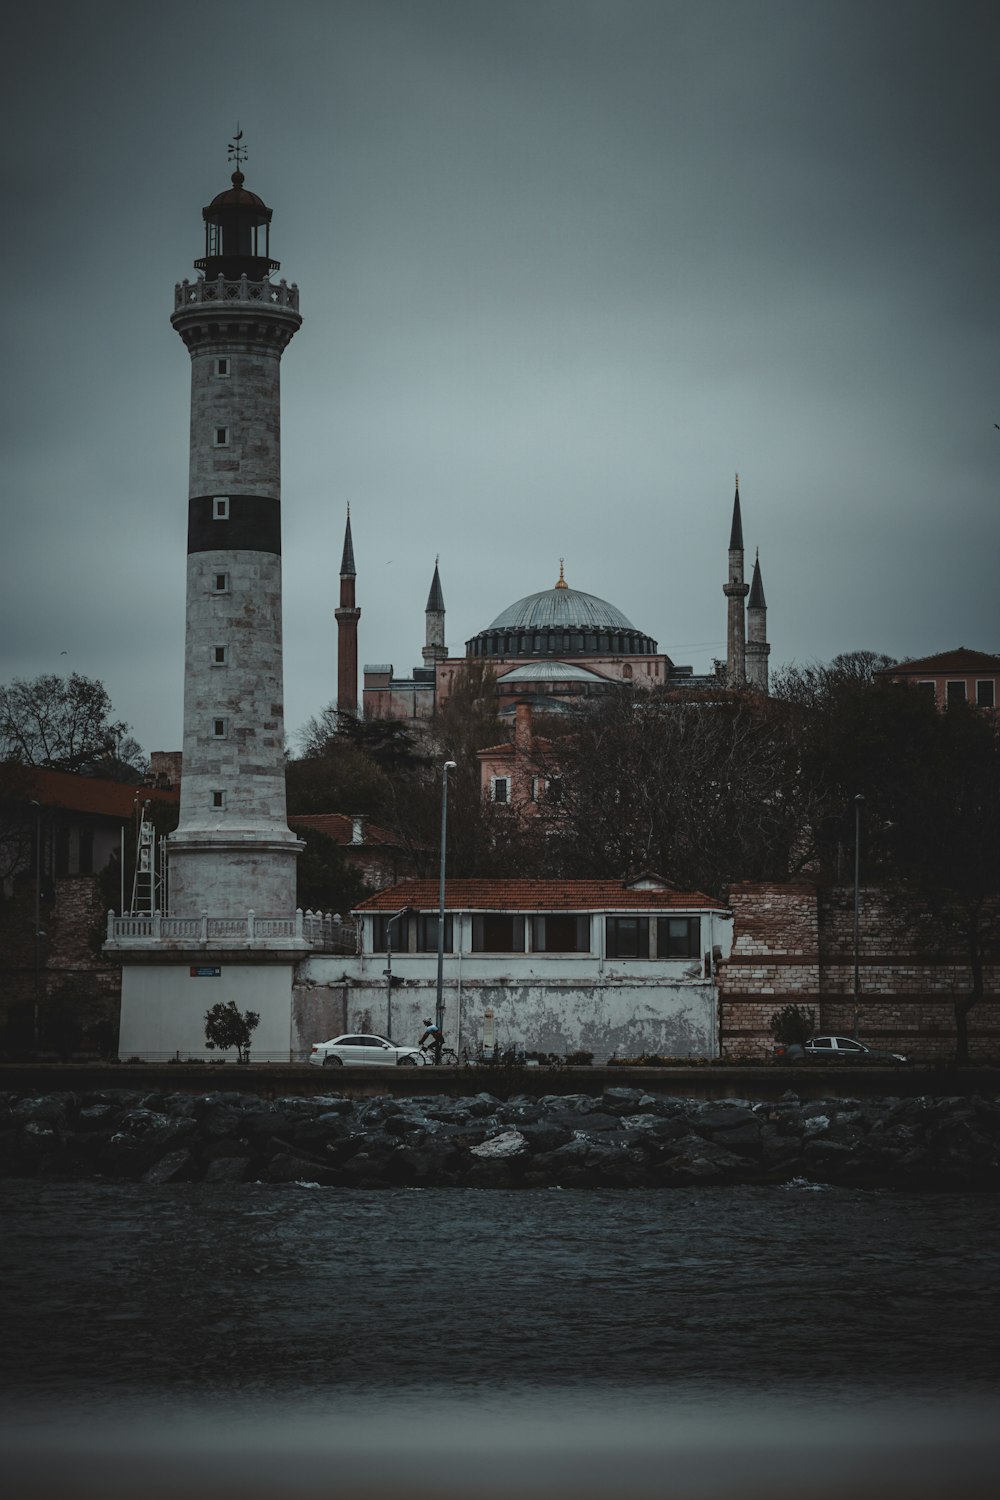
{"left": 106, "top": 908, "right": 360, "bottom": 954}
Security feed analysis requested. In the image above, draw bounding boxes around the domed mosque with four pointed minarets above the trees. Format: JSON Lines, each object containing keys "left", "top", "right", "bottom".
{"left": 336, "top": 476, "right": 771, "bottom": 725}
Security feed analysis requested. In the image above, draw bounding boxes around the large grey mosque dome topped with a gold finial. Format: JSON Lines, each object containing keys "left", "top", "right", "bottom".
{"left": 466, "top": 567, "right": 657, "bottom": 657}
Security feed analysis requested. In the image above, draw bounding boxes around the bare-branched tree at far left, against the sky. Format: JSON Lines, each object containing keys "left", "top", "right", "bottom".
{"left": 0, "top": 672, "right": 145, "bottom": 776}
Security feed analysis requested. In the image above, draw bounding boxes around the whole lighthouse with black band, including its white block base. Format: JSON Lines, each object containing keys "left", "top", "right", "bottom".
{"left": 105, "top": 134, "right": 313, "bottom": 1062}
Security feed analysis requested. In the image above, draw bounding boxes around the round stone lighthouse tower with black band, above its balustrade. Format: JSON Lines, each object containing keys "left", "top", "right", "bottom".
{"left": 168, "top": 146, "right": 303, "bottom": 912}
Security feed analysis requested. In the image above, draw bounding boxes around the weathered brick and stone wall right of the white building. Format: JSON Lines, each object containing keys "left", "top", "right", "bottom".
{"left": 718, "top": 882, "right": 1000, "bottom": 1061}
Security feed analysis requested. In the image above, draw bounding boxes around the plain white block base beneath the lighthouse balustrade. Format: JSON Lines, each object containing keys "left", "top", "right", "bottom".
{"left": 118, "top": 953, "right": 295, "bottom": 1062}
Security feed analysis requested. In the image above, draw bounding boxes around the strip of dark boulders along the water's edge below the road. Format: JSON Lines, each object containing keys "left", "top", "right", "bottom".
{"left": 0, "top": 1088, "right": 1000, "bottom": 1190}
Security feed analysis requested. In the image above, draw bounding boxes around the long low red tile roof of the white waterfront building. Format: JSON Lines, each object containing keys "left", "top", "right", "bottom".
{"left": 355, "top": 881, "right": 726, "bottom": 912}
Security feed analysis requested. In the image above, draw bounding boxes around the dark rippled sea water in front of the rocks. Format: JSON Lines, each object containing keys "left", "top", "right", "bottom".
{"left": 0, "top": 1182, "right": 1000, "bottom": 1500}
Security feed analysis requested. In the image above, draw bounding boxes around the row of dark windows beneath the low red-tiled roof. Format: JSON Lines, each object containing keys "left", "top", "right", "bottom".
{"left": 372, "top": 912, "right": 702, "bottom": 959}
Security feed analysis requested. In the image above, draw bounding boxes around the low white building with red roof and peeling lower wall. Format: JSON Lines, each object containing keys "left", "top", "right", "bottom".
{"left": 294, "top": 875, "right": 733, "bottom": 1062}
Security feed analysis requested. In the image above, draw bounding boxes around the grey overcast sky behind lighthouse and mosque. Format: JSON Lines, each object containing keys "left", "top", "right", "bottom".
{"left": 0, "top": 0, "right": 1000, "bottom": 750}
